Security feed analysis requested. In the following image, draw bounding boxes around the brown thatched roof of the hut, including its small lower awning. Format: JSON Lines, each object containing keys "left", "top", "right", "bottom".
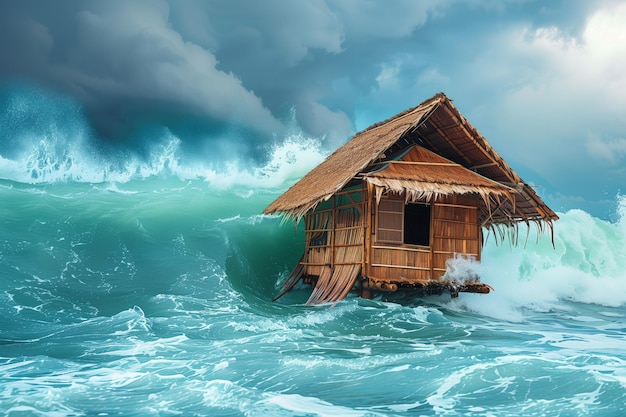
{"left": 264, "top": 93, "right": 558, "bottom": 226}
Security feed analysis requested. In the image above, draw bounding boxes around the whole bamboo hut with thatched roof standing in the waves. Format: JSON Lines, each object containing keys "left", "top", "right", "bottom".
{"left": 264, "top": 94, "right": 558, "bottom": 304}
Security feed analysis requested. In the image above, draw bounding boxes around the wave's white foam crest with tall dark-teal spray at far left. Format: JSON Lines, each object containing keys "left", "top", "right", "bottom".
{"left": 0, "top": 83, "right": 327, "bottom": 188}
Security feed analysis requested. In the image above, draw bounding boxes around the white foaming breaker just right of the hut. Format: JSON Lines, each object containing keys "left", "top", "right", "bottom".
{"left": 454, "top": 196, "right": 626, "bottom": 321}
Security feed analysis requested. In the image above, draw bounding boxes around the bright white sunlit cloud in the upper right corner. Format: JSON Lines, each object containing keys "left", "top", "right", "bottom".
{"left": 496, "top": 5, "right": 626, "bottom": 143}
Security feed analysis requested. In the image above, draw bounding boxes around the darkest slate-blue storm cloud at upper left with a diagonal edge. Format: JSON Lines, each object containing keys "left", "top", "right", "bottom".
{"left": 0, "top": 1, "right": 281, "bottom": 141}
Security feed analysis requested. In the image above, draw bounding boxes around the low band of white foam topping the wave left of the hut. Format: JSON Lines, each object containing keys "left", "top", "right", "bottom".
{"left": 0, "top": 128, "right": 325, "bottom": 190}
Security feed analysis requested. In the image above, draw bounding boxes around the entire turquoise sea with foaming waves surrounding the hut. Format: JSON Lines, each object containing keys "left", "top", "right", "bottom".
{"left": 0, "top": 88, "right": 626, "bottom": 417}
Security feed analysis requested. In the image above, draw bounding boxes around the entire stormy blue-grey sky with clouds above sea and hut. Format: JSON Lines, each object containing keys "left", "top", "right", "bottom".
{"left": 0, "top": 0, "right": 626, "bottom": 218}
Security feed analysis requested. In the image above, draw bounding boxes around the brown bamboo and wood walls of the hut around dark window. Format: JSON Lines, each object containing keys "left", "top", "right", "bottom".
{"left": 302, "top": 189, "right": 481, "bottom": 283}
